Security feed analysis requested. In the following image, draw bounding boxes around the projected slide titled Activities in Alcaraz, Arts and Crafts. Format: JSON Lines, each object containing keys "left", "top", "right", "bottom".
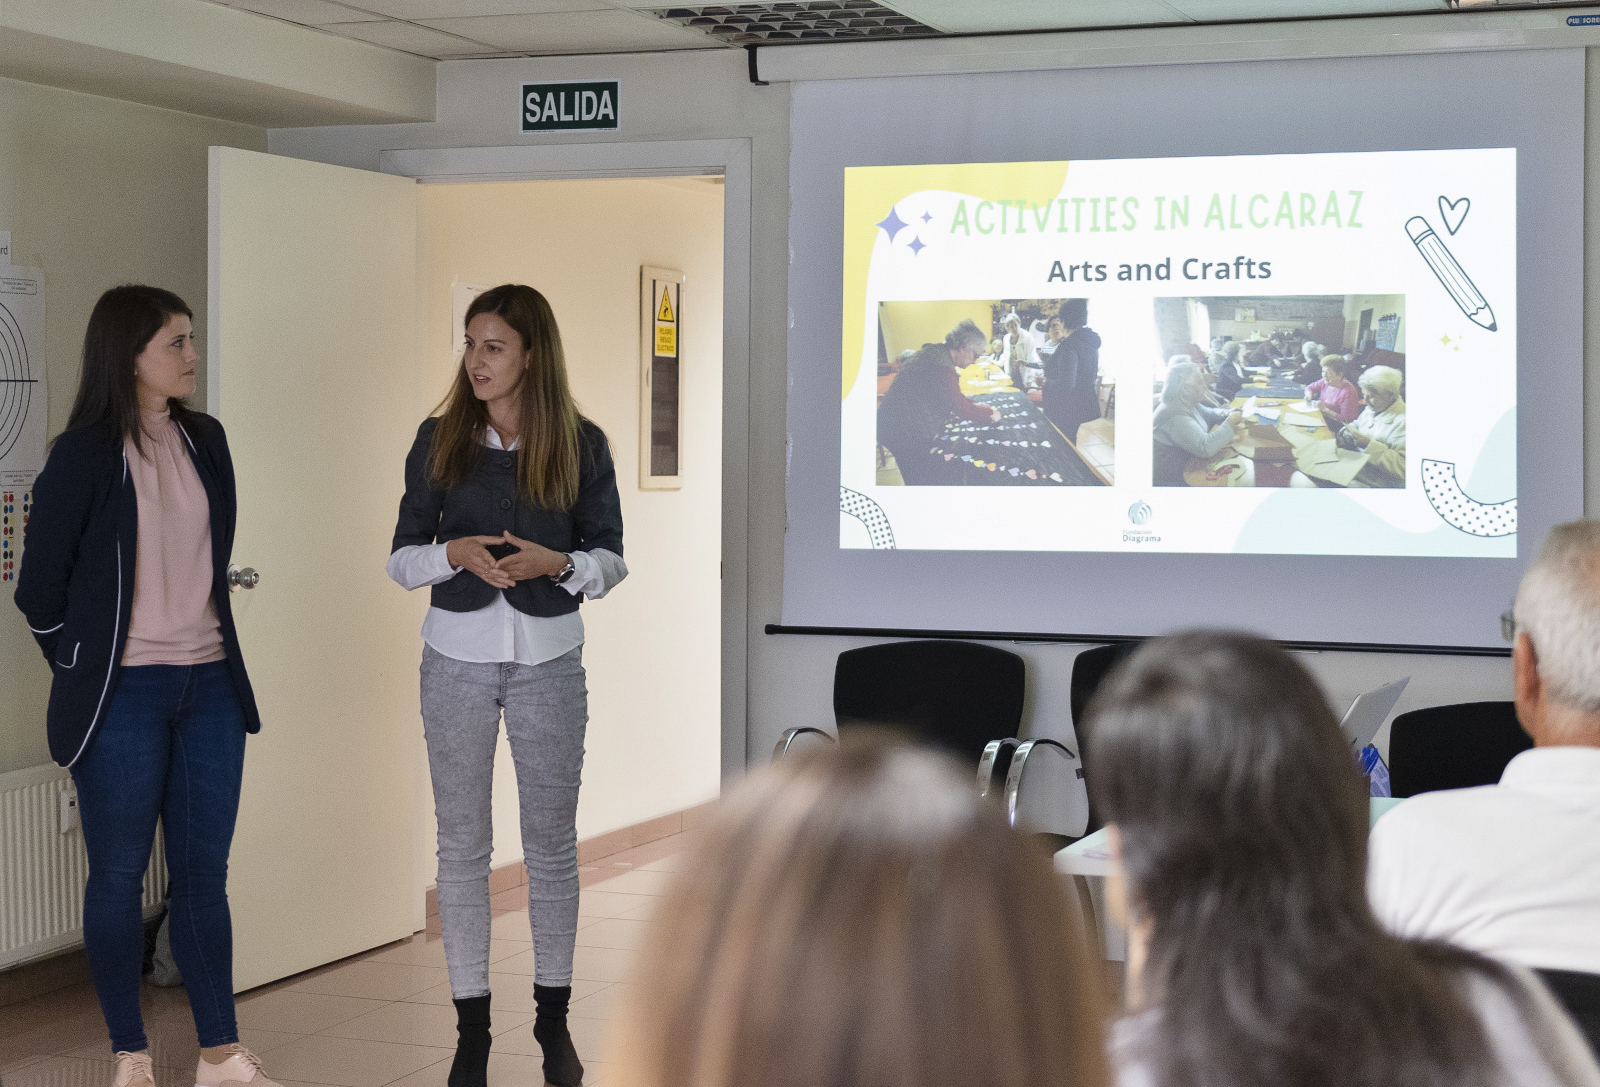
{"left": 840, "top": 149, "right": 1517, "bottom": 557}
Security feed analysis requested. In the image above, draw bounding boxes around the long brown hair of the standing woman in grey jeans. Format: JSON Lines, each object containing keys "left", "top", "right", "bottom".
{"left": 427, "top": 283, "right": 584, "bottom": 509}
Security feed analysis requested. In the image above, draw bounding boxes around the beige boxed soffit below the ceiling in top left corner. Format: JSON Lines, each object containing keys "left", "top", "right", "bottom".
{"left": 0, "top": 0, "right": 435, "bottom": 128}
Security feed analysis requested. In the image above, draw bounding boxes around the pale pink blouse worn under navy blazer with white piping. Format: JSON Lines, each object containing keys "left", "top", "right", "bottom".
{"left": 122, "top": 410, "right": 226, "bottom": 668}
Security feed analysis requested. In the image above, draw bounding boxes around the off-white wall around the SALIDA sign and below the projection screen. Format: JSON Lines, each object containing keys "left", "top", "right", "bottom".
{"left": 270, "top": 38, "right": 1600, "bottom": 770}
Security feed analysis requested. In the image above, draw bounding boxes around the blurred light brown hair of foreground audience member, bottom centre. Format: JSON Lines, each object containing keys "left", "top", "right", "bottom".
{"left": 604, "top": 740, "right": 1107, "bottom": 1087}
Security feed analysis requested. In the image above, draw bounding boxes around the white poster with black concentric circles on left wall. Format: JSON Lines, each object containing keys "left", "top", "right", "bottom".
{"left": 0, "top": 267, "right": 46, "bottom": 491}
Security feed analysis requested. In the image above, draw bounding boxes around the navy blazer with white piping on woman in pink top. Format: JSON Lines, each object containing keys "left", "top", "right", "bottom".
{"left": 16, "top": 411, "right": 261, "bottom": 767}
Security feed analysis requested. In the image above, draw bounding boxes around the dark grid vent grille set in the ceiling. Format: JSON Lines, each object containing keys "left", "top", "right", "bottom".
{"left": 654, "top": 0, "right": 938, "bottom": 45}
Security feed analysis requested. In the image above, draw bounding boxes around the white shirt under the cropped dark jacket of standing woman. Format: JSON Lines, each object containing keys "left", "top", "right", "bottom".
{"left": 386, "top": 427, "right": 627, "bottom": 664}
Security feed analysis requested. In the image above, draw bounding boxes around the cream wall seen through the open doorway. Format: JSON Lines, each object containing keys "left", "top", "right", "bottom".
{"left": 419, "top": 178, "right": 722, "bottom": 872}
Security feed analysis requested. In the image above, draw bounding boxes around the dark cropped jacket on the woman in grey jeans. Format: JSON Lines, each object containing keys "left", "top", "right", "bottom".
{"left": 389, "top": 418, "right": 622, "bottom": 616}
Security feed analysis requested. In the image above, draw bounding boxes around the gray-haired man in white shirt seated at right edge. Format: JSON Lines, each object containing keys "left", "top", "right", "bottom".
{"left": 1368, "top": 520, "right": 1600, "bottom": 973}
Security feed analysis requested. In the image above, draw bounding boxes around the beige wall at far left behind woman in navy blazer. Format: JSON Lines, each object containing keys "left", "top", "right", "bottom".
{"left": 0, "top": 80, "right": 267, "bottom": 773}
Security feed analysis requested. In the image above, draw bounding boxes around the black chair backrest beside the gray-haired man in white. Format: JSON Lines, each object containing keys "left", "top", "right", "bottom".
{"left": 1389, "top": 703, "right": 1533, "bottom": 796}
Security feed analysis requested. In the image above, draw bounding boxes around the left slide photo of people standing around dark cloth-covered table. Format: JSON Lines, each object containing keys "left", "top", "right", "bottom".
{"left": 877, "top": 298, "right": 1115, "bottom": 487}
